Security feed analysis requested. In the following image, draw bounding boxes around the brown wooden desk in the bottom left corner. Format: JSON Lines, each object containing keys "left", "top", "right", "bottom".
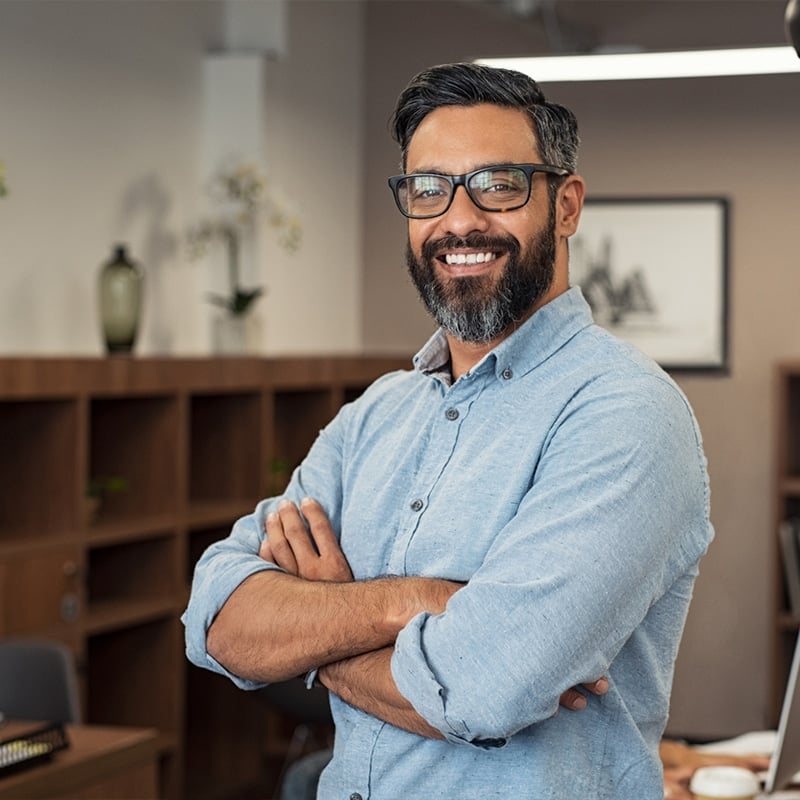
{"left": 0, "top": 721, "right": 158, "bottom": 800}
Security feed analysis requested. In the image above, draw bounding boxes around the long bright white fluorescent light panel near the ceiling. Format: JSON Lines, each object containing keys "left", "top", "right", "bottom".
{"left": 477, "top": 47, "right": 800, "bottom": 83}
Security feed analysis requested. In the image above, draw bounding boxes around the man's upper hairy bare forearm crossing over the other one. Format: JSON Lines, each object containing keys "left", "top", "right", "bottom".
{"left": 206, "top": 570, "right": 458, "bottom": 682}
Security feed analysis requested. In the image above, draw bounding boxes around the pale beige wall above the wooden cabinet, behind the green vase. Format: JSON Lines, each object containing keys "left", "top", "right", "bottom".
{"left": 0, "top": 0, "right": 363, "bottom": 355}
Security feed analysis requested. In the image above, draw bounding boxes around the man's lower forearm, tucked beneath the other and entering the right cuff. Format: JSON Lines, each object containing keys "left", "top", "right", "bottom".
{"left": 319, "top": 647, "right": 444, "bottom": 739}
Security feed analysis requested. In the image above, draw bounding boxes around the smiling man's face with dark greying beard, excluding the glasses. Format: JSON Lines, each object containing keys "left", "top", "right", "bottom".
{"left": 406, "top": 104, "right": 555, "bottom": 342}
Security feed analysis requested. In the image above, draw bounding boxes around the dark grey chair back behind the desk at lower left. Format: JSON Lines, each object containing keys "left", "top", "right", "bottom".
{"left": 0, "top": 639, "right": 81, "bottom": 722}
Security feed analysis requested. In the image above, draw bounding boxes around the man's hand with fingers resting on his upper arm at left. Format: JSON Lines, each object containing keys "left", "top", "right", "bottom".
{"left": 258, "top": 497, "right": 353, "bottom": 583}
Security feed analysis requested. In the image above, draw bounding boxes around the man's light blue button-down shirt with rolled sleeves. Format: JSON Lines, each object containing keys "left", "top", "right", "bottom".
{"left": 183, "top": 289, "right": 712, "bottom": 800}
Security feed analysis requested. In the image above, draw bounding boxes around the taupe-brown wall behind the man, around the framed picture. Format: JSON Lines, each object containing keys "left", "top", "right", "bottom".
{"left": 364, "top": 2, "right": 800, "bottom": 737}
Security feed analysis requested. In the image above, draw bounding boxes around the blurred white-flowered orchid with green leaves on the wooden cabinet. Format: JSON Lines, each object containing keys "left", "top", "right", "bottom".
{"left": 188, "top": 163, "right": 302, "bottom": 350}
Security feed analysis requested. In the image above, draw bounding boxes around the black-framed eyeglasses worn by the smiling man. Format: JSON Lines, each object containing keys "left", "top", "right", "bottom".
{"left": 389, "top": 164, "right": 570, "bottom": 219}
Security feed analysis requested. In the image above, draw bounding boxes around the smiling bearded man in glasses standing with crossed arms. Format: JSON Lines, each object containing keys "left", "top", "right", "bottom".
{"left": 184, "top": 64, "right": 712, "bottom": 800}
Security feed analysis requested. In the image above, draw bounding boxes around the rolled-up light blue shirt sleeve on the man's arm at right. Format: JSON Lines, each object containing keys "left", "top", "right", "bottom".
{"left": 392, "top": 377, "right": 710, "bottom": 746}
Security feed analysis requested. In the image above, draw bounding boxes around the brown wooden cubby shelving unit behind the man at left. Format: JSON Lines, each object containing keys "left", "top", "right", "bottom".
{"left": 0, "top": 356, "right": 410, "bottom": 800}
